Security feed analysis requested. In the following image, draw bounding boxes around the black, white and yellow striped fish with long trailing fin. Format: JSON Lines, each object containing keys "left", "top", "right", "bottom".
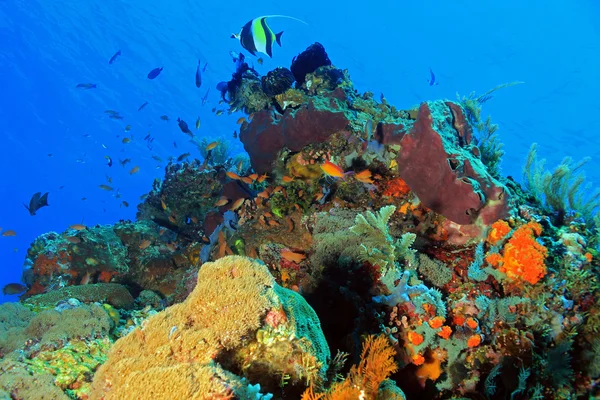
{"left": 231, "top": 15, "right": 306, "bottom": 57}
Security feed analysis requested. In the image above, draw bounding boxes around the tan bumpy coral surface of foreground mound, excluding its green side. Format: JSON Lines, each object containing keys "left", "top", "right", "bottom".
{"left": 90, "top": 256, "right": 329, "bottom": 400}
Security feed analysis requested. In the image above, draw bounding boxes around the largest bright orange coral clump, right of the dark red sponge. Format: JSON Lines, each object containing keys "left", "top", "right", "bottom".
{"left": 486, "top": 222, "right": 548, "bottom": 285}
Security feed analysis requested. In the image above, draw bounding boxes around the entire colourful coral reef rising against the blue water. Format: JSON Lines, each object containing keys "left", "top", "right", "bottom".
{"left": 5, "top": 43, "right": 600, "bottom": 400}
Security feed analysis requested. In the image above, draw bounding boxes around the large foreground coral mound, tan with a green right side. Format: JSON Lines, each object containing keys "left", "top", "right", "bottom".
{"left": 91, "top": 256, "right": 330, "bottom": 400}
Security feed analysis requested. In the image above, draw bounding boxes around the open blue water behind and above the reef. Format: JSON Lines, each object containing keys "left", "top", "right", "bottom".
{"left": 0, "top": 0, "right": 600, "bottom": 301}
